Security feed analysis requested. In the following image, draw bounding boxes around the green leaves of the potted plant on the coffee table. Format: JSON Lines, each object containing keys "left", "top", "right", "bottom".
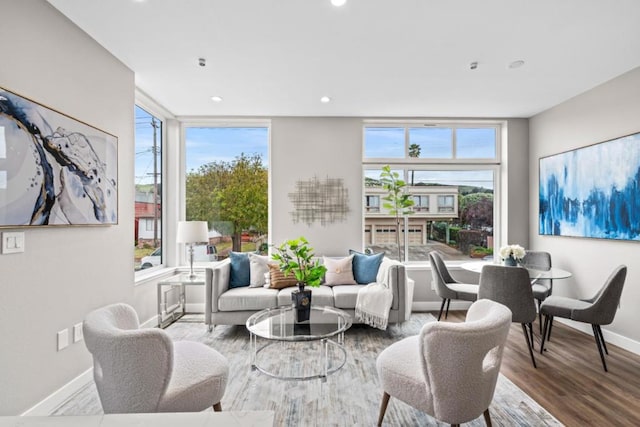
{"left": 271, "top": 237, "right": 327, "bottom": 287}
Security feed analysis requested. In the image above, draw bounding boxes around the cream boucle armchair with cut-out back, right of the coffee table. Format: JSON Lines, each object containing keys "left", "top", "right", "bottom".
{"left": 376, "top": 300, "right": 511, "bottom": 426}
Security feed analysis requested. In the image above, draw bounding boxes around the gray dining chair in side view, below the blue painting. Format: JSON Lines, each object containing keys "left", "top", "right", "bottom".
{"left": 540, "top": 265, "right": 627, "bottom": 372}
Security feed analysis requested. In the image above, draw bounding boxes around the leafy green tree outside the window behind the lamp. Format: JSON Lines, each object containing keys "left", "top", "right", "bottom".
{"left": 186, "top": 153, "right": 268, "bottom": 251}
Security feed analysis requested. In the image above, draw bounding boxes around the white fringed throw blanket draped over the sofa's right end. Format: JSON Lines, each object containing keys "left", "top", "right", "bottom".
{"left": 356, "top": 259, "right": 396, "bottom": 330}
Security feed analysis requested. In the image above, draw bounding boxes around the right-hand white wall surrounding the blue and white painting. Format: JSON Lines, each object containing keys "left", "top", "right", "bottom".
{"left": 529, "top": 68, "right": 640, "bottom": 351}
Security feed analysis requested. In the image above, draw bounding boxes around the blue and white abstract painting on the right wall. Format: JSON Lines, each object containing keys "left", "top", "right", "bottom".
{"left": 539, "top": 133, "right": 640, "bottom": 241}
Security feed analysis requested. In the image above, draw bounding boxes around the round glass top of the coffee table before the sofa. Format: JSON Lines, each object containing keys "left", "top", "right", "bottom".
{"left": 247, "top": 306, "right": 352, "bottom": 341}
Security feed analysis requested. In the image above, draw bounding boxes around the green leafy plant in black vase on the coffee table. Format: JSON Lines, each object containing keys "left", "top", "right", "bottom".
{"left": 271, "top": 237, "right": 327, "bottom": 322}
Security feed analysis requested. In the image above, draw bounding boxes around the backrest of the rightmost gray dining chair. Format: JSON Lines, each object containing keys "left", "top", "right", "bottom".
{"left": 571, "top": 265, "right": 627, "bottom": 325}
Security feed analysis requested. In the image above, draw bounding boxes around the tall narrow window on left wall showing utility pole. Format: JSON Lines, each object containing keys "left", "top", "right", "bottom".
{"left": 134, "top": 105, "right": 163, "bottom": 271}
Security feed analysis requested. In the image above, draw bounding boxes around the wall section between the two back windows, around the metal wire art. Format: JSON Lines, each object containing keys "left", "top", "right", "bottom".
{"left": 269, "top": 118, "right": 363, "bottom": 256}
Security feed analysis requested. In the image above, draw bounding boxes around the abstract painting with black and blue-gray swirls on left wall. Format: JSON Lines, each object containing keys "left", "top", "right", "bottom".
{"left": 0, "top": 88, "right": 118, "bottom": 227}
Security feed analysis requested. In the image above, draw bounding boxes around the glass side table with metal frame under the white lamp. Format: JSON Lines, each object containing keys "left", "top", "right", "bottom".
{"left": 158, "top": 273, "right": 206, "bottom": 328}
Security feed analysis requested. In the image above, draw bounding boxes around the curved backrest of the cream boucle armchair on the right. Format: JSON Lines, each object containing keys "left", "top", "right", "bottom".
{"left": 420, "top": 300, "right": 511, "bottom": 422}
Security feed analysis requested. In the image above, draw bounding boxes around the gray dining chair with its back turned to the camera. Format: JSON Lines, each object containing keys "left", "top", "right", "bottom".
{"left": 478, "top": 265, "right": 537, "bottom": 368}
